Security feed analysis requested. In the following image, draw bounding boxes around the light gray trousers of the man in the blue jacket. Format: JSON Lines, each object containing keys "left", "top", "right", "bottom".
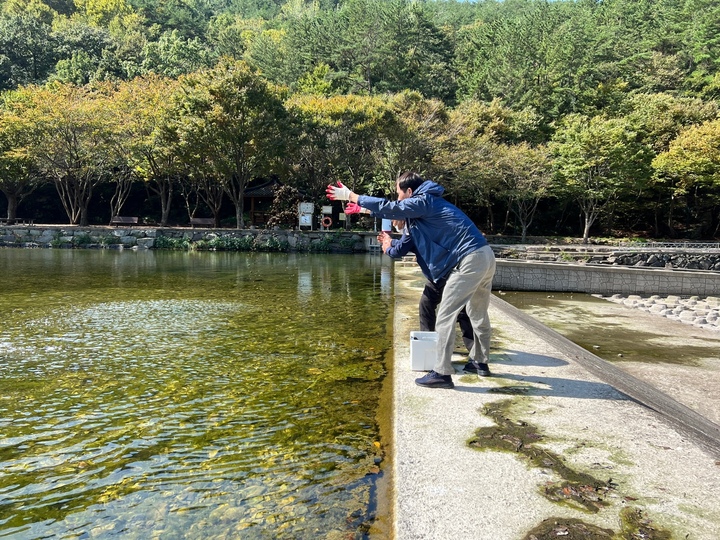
{"left": 433, "top": 246, "right": 495, "bottom": 375}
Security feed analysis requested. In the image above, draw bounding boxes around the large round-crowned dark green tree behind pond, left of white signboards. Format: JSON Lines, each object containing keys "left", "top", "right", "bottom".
{"left": 172, "top": 59, "right": 287, "bottom": 228}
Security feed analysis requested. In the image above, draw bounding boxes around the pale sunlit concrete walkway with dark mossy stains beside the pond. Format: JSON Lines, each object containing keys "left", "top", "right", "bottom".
{"left": 392, "top": 265, "right": 720, "bottom": 540}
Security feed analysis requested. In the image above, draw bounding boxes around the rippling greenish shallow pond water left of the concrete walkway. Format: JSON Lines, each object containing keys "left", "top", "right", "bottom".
{"left": 0, "top": 249, "right": 392, "bottom": 539}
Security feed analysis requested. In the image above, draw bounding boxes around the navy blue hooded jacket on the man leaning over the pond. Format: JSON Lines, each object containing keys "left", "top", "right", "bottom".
{"left": 358, "top": 180, "right": 487, "bottom": 282}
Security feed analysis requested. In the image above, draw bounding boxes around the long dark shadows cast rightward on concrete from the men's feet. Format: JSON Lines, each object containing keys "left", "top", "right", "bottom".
{"left": 455, "top": 350, "right": 631, "bottom": 400}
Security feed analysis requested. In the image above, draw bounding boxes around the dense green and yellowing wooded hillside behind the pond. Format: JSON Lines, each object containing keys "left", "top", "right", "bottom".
{"left": 0, "top": 0, "right": 720, "bottom": 238}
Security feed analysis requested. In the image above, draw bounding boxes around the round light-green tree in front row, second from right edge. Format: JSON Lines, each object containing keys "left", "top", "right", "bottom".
{"left": 551, "top": 114, "right": 650, "bottom": 243}
